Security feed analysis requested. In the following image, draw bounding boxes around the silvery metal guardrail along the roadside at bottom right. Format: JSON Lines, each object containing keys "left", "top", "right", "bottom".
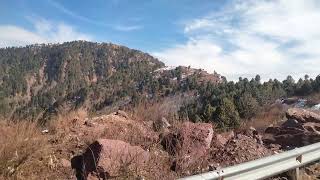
{"left": 181, "top": 142, "right": 320, "bottom": 180}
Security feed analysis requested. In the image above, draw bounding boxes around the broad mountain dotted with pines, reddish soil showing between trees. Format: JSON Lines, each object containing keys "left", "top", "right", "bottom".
{"left": 0, "top": 41, "right": 220, "bottom": 122}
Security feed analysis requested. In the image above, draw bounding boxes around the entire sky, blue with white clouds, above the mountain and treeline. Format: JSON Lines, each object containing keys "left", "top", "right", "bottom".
{"left": 0, "top": 0, "right": 320, "bottom": 80}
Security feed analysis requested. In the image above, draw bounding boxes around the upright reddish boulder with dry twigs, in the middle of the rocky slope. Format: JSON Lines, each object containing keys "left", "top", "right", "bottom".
{"left": 161, "top": 122, "right": 213, "bottom": 172}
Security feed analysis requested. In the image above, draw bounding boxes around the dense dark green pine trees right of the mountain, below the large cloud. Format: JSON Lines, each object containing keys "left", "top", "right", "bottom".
{"left": 179, "top": 75, "right": 320, "bottom": 129}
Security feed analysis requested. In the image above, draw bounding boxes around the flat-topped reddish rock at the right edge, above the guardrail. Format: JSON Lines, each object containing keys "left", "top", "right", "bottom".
{"left": 286, "top": 108, "right": 320, "bottom": 123}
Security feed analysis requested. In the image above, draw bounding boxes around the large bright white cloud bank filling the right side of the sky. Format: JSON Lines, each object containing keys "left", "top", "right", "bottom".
{"left": 154, "top": 0, "right": 320, "bottom": 80}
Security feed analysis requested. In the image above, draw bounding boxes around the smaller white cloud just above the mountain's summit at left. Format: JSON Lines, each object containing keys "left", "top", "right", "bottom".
{"left": 0, "top": 18, "right": 92, "bottom": 47}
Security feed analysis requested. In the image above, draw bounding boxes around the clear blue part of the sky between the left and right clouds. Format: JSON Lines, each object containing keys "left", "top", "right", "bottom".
{"left": 0, "top": 0, "right": 223, "bottom": 51}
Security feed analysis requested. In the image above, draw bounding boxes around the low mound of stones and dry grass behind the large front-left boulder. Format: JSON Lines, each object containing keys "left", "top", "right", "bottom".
{"left": 68, "top": 111, "right": 159, "bottom": 149}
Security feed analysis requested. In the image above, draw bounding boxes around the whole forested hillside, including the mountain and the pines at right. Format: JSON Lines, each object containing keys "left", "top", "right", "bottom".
{"left": 0, "top": 41, "right": 320, "bottom": 129}
